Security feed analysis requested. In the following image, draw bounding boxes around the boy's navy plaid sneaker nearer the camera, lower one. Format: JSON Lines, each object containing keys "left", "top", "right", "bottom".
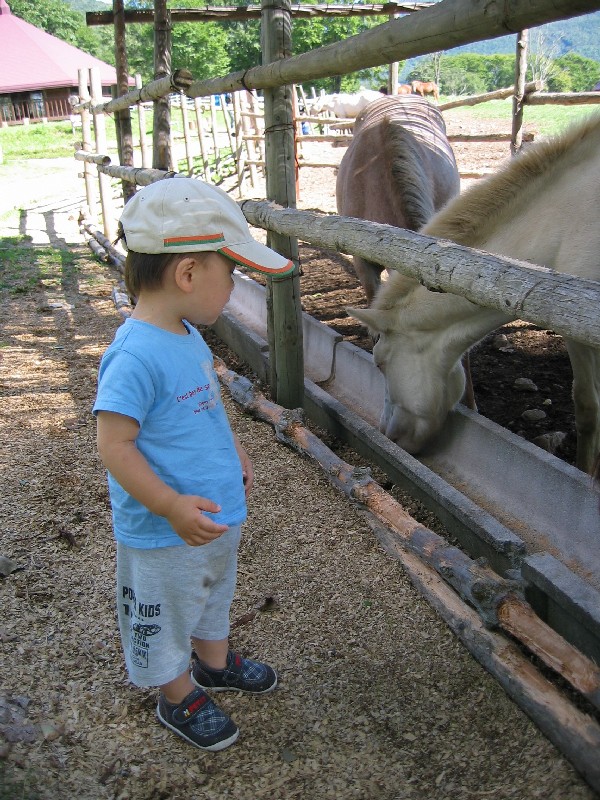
{"left": 156, "top": 689, "right": 240, "bottom": 751}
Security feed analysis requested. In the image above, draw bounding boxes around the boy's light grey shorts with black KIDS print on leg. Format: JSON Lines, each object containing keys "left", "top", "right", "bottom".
{"left": 117, "top": 525, "right": 241, "bottom": 686}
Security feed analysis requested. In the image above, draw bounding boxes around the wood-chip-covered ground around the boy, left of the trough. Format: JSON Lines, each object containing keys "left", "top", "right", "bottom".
{"left": 0, "top": 112, "right": 596, "bottom": 800}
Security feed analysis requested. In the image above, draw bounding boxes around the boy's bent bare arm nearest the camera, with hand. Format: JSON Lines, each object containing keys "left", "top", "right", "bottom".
{"left": 97, "top": 411, "right": 227, "bottom": 546}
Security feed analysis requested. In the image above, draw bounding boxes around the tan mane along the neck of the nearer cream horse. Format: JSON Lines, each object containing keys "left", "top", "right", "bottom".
{"left": 420, "top": 114, "right": 600, "bottom": 246}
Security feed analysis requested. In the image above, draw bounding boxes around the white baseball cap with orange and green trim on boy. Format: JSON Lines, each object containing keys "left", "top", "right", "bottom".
{"left": 121, "top": 175, "right": 294, "bottom": 275}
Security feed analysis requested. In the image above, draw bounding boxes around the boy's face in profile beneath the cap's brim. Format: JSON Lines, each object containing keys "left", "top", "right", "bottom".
{"left": 186, "top": 252, "right": 235, "bottom": 325}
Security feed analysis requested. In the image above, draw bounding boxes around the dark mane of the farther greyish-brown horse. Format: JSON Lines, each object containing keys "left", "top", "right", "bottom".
{"left": 386, "top": 118, "right": 435, "bottom": 231}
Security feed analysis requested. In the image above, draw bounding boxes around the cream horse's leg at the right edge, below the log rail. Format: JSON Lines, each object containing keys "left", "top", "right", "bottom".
{"left": 565, "top": 339, "right": 600, "bottom": 473}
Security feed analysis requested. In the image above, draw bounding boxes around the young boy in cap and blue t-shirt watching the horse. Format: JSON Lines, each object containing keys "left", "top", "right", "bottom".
{"left": 94, "top": 177, "right": 294, "bottom": 750}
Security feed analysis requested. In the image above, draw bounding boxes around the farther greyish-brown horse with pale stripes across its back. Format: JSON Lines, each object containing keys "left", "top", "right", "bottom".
{"left": 336, "top": 95, "right": 460, "bottom": 302}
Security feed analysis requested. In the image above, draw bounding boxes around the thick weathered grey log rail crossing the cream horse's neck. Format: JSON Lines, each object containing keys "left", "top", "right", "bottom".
{"left": 242, "top": 200, "right": 600, "bottom": 347}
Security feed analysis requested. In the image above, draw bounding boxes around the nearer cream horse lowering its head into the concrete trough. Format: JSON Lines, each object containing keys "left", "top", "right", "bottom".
{"left": 350, "top": 115, "right": 600, "bottom": 472}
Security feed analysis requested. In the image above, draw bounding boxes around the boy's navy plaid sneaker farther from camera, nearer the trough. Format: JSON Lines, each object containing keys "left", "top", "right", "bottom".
{"left": 192, "top": 650, "right": 277, "bottom": 694}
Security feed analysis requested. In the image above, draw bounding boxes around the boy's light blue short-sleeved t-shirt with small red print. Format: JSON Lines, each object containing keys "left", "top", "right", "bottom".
{"left": 93, "top": 319, "right": 246, "bottom": 549}
